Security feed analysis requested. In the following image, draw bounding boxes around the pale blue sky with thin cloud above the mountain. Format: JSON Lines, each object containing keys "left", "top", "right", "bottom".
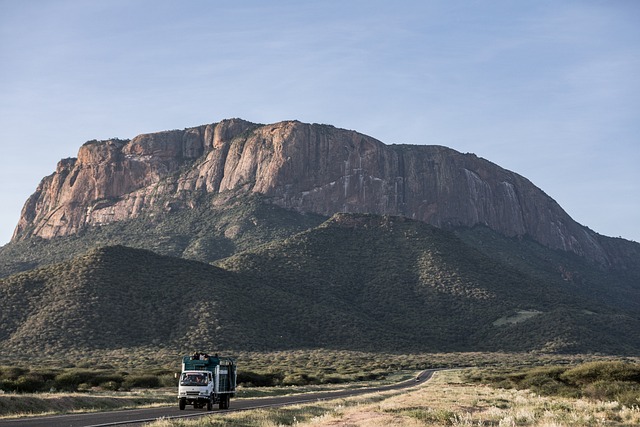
{"left": 0, "top": 0, "right": 640, "bottom": 245}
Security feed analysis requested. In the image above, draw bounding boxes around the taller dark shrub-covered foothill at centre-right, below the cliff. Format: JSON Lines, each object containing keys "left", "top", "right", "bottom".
{"left": 219, "top": 214, "right": 640, "bottom": 353}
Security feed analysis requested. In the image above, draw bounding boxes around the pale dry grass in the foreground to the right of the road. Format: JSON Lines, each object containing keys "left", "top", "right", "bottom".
{"left": 150, "top": 370, "right": 640, "bottom": 427}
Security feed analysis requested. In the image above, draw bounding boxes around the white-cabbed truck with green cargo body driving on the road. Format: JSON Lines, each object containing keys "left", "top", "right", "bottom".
{"left": 178, "top": 352, "right": 237, "bottom": 411}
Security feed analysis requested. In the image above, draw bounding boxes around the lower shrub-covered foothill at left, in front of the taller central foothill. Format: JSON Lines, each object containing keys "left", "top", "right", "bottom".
{"left": 0, "top": 246, "right": 344, "bottom": 355}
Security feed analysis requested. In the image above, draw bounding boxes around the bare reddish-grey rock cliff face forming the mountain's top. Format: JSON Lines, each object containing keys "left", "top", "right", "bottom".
{"left": 13, "top": 119, "right": 609, "bottom": 263}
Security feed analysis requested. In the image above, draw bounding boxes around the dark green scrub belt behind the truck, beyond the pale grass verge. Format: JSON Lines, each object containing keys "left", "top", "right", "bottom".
{"left": 0, "top": 348, "right": 600, "bottom": 393}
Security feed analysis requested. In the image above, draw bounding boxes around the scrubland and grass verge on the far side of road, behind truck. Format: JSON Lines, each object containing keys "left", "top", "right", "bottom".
{"left": 0, "top": 347, "right": 490, "bottom": 417}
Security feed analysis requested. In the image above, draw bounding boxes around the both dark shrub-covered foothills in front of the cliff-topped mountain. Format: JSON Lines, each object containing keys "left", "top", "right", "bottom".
{"left": 0, "top": 214, "right": 640, "bottom": 354}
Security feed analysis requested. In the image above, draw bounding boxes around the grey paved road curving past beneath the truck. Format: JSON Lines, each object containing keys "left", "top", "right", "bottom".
{"left": 0, "top": 369, "right": 435, "bottom": 427}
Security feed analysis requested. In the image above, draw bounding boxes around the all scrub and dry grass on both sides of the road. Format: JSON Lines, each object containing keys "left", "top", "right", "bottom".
{"left": 0, "top": 349, "right": 640, "bottom": 427}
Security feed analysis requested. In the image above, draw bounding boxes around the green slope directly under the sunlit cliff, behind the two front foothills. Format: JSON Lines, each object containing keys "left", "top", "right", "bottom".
{"left": 0, "top": 193, "right": 326, "bottom": 277}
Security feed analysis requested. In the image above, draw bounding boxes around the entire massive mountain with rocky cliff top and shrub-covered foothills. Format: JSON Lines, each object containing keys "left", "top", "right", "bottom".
{"left": 0, "top": 119, "right": 640, "bottom": 355}
